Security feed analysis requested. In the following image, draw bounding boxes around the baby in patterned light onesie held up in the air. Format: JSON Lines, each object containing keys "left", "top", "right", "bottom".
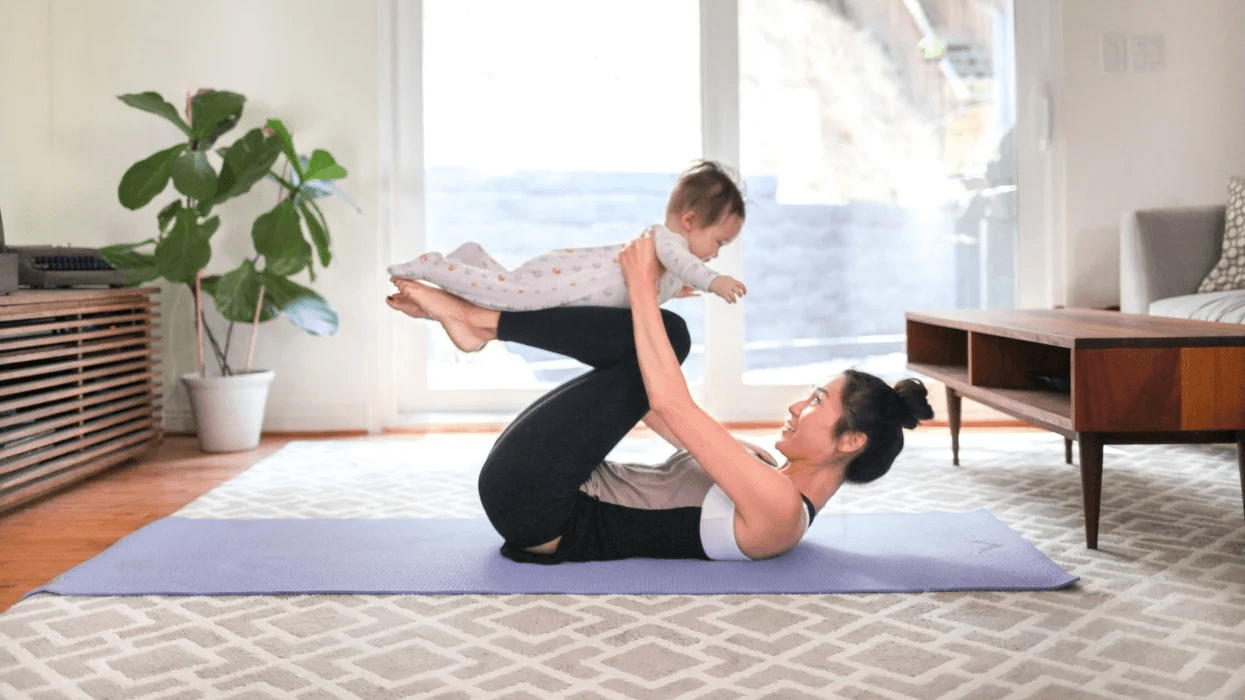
{"left": 388, "top": 161, "right": 747, "bottom": 311}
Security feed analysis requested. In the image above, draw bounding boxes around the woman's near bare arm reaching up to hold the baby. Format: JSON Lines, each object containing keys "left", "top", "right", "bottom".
{"left": 620, "top": 237, "right": 803, "bottom": 559}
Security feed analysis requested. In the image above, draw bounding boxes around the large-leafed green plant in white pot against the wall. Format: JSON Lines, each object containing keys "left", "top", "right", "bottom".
{"left": 101, "top": 90, "right": 356, "bottom": 452}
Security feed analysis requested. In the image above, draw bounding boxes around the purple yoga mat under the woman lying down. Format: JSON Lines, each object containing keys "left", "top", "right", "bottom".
{"left": 26, "top": 509, "right": 1076, "bottom": 595}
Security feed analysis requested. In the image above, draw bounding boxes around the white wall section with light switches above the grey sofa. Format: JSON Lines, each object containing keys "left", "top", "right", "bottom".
{"left": 1055, "top": 0, "right": 1245, "bottom": 306}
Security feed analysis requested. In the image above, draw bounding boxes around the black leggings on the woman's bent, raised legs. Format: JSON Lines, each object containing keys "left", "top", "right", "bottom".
{"left": 479, "top": 306, "right": 692, "bottom": 548}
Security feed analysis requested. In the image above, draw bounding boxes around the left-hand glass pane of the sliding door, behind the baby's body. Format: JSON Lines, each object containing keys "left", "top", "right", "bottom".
{"left": 423, "top": 0, "right": 703, "bottom": 389}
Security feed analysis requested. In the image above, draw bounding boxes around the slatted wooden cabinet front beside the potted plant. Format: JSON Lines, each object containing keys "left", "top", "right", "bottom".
{"left": 0, "top": 289, "right": 162, "bottom": 512}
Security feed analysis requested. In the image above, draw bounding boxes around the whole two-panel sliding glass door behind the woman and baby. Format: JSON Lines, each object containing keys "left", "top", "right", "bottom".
{"left": 396, "top": 0, "right": 1016, "bottom": 419}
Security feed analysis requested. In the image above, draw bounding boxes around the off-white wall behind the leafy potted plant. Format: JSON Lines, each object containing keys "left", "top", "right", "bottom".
{"left": 0, "top": 0, "right": 388, "bottom": 431}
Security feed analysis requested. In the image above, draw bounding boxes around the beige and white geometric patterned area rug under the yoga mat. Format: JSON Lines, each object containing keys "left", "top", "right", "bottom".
{"left": 0, "top": 430, "right": 1245, "bottom": 700}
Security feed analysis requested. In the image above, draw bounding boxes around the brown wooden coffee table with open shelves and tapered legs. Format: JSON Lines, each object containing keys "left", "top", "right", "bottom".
{"left": 906, "top": 309, "right": 1245, "bottom": 549}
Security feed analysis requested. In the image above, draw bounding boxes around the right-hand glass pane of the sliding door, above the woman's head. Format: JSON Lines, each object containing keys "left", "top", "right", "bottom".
{"left": 740, "top": 0, "right": 1016, "bottom": 384}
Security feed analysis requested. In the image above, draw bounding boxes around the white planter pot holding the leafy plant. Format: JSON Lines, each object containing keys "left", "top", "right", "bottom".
{"left": 182, "top": 370, "right": 275, "bottom": 452}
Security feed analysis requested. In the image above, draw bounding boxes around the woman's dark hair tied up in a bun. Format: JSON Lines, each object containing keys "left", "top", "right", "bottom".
{"left": 834, "top": 370, "right": 934, "bottom": 483}
